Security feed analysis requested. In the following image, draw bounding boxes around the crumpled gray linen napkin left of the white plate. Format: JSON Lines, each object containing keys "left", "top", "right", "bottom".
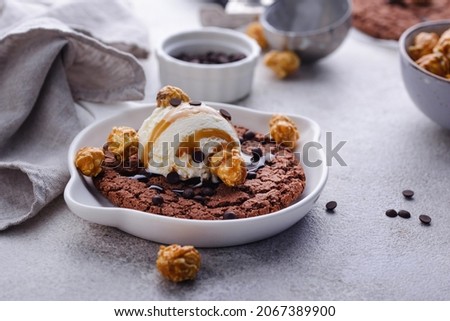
{"left": 0, "top": 0, "right": 148, "bottom": 230}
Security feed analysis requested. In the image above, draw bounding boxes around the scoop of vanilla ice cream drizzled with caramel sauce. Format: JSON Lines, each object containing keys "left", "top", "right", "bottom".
{"left": 139, "top": 102, "right": 240, "bottom": 180}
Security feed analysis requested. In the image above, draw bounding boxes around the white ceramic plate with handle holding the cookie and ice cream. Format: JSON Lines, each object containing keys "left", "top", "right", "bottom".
{"left": 64, "top": 103, "right": 328, "bottom": 247}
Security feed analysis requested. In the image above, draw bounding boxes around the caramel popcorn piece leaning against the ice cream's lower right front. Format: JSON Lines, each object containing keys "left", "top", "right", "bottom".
{"left": 210, "top": 148, "right": 247, "bottom": 186}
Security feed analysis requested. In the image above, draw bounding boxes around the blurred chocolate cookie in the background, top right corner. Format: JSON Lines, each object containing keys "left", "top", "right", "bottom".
{"left": 352, "top": 0, "right": 450, "bottom": 40}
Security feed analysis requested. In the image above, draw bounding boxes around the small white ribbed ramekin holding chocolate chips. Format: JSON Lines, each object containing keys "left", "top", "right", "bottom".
{"left": 156, "top": 27, "right": 261, "bottom": 102}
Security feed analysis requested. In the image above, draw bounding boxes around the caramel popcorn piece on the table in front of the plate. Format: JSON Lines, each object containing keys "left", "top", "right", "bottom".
{"left": 156, "top": 244, "right": 201, "bottom": 282}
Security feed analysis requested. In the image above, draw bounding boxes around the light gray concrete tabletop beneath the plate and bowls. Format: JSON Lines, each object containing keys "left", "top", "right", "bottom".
{"left": 0, "top": 0, "right": 450, "bottom": 300}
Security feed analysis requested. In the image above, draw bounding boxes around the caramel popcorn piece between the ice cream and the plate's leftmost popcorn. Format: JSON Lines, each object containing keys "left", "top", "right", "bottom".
{"left": 107, "top": 126, "right": 139, "bottom": 160}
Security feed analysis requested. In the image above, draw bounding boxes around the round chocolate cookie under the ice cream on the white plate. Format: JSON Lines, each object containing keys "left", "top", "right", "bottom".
{"left": 93, "top": 127, "right": 305, "bottom": 220}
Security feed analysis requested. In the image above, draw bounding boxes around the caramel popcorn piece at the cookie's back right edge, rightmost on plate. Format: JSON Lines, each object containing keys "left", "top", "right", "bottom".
{"left": 269, "top": 115, "right": 300, "bottom": 149}
